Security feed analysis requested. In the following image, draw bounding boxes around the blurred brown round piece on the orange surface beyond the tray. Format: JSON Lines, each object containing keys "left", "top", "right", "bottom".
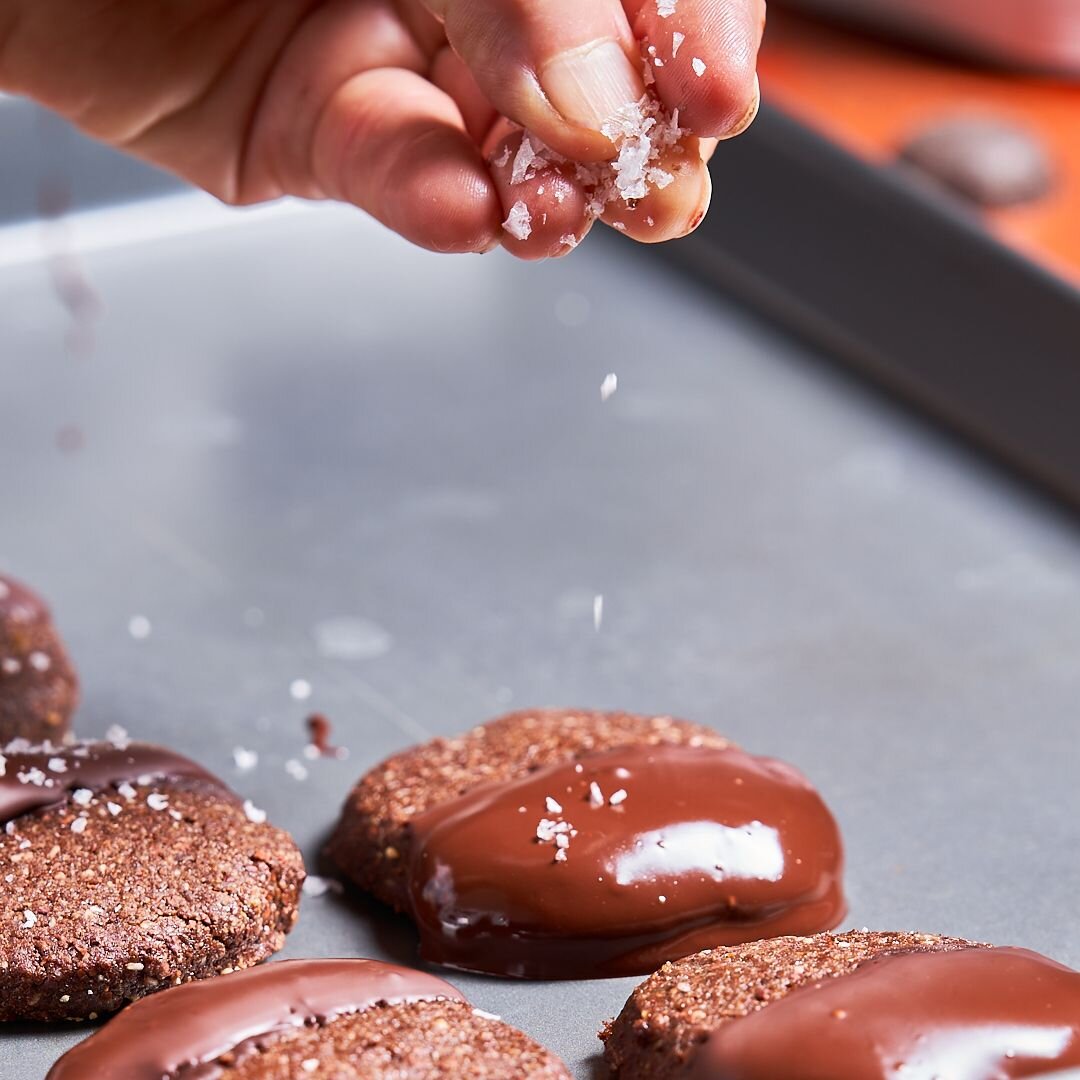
{"left": 900, "top": 116, "right": 1053, "bottom": 208}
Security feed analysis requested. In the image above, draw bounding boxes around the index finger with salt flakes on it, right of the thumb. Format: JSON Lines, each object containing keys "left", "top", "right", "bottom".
{"left": 623, "top": 0, "right": 765, "bottom": 138}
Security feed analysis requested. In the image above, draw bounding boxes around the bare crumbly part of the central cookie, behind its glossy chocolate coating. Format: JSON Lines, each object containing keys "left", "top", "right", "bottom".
{"left": 319, "top": 708, "right": 729, "bottom": 910}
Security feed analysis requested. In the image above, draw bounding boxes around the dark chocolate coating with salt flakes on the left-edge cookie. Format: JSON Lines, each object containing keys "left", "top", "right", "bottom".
{"left": 0, "top": 741, "right": 225, "bottom": 824}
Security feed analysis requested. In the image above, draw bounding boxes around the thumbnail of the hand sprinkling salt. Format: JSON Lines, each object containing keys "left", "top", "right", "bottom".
{"left": 540, "top": 41, "right": 645, "bottom": 132}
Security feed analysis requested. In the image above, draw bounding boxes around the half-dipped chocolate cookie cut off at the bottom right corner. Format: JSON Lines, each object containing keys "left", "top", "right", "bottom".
{"left": 600, "top": 931, "right": 1080, "bottom": 1080}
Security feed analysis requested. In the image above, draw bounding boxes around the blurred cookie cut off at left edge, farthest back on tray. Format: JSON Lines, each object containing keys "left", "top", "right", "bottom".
{"left": 0, "top": 575, "right": 79, "bottom": 746}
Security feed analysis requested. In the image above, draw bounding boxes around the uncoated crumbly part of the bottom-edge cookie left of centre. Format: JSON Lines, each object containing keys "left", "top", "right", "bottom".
{"left": 222, "top": 1001, "right": 570, "bottom": 1080}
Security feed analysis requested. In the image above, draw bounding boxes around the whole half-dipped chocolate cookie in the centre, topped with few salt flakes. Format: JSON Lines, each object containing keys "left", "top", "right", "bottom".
{"left": 327, "top": 710, "right": 845, "bottom": 978}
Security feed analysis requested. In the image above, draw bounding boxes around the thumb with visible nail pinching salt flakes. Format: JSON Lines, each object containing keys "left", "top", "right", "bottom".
{"left": 416, "top": 0, "right": 645, "bottom": 161}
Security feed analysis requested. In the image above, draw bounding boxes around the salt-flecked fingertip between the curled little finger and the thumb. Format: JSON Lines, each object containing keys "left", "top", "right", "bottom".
{"left": 488, "top": 121, "right": 592, "bottom": 259}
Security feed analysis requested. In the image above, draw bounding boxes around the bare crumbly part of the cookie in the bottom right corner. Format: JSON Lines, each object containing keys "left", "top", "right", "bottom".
{"left": 600, "top": 930, "right": 981, "bottom": 1080}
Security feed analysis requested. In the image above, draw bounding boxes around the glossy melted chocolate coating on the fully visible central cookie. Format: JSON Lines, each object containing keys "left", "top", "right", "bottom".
{"left": 409, "top": 746, "right": 845, "bottom": 978}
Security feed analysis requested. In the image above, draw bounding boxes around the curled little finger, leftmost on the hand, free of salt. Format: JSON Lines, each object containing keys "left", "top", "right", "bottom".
{"left": 312, "top": 68, "right": 502, "bottom": 252}
